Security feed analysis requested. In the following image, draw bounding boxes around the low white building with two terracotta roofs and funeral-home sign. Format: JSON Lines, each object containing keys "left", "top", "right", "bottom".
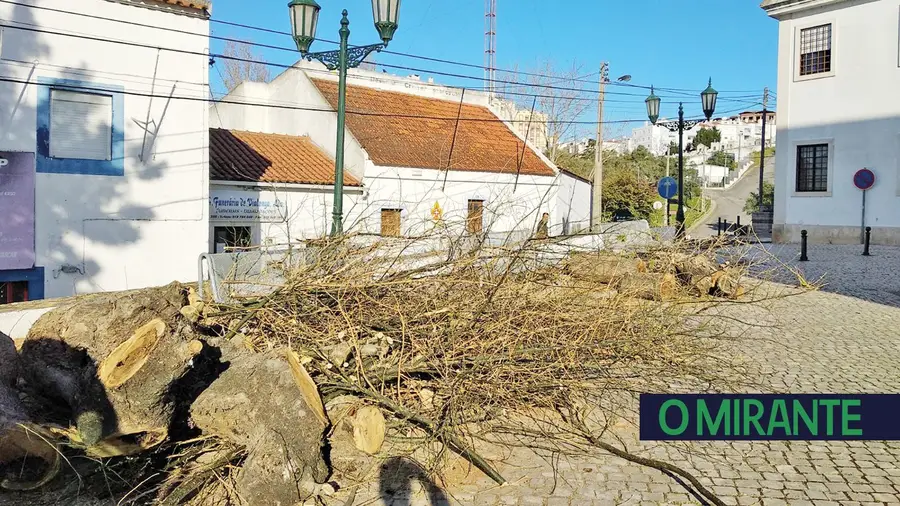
{"left": 210, "top": 63, "right": 590, "bottom": 243}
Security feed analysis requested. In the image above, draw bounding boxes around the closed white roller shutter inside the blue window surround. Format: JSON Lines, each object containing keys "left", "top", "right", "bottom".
{"left": 50, "top": 90, "right": 112, "bottom": 160}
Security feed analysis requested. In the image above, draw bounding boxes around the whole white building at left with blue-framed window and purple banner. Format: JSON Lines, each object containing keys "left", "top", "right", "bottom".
{"left": 0, "top": 0, "right": 209, "bottom": 302}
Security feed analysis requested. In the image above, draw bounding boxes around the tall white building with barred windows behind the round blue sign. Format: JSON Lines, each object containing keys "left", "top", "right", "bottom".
{"left": 762, "top": 0, "right": 900, "bottom": 244}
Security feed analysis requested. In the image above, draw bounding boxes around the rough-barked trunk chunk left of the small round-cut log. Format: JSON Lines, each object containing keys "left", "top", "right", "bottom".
{"left": 191, "top": 342, "right": 329, "bottom": 505}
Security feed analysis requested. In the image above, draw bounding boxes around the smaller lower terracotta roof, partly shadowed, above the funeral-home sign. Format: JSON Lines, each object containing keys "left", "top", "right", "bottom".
{"left": 209, "top": 128, "right": 360, "bottom": 186}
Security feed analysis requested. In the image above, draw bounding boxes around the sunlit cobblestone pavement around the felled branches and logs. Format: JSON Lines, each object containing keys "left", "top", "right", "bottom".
{"left": 341, "top": 247, "right": 900, "bottom": 506}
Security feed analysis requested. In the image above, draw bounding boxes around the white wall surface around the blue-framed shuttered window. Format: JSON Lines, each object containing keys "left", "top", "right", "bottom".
{"left": 0, "top": 0, "right": 209, "bottom": 297}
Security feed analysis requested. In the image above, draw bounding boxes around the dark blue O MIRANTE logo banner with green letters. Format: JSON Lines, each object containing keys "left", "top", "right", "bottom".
{"left": 640, "top": 394, "right": 900, "bottom": 441}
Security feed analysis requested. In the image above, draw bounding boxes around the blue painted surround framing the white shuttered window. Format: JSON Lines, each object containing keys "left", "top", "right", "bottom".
{"left": 37, "top": 77, "right": 125, "bottom": 176}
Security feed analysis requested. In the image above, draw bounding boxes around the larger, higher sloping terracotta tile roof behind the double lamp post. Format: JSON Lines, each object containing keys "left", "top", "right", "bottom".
{"left": 312, "top": 79, "right": 555, "bottom": 176}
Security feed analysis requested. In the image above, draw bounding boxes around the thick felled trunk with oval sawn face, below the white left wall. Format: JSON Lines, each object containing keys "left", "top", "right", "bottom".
{"left": 20, "top": 283, "right": 201, "bottom": 448}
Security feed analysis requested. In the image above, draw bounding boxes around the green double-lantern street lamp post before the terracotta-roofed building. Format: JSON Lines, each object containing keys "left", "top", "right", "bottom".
{"left": 288, "top": 0, "right": 400, "bottom": 237}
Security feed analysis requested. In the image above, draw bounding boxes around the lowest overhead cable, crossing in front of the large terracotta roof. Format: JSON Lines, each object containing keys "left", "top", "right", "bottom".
{"left": 0, "top": 76, "right": 660, "bottom": 125}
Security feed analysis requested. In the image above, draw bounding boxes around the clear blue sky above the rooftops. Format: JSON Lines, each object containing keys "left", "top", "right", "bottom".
{"left": 211, "top": 0, "right": 778, "bottom": 138}
